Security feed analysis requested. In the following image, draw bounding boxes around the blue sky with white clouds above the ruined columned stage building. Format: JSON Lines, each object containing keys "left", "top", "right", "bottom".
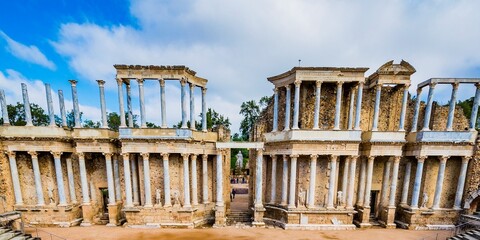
{"left": 0, "top": 0, "right": 480, "bottom": 132}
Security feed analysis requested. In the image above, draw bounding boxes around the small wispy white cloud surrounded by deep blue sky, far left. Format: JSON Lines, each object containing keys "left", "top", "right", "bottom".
{"left": 0, "top": 31, "right": 56, "bottom": 70}
